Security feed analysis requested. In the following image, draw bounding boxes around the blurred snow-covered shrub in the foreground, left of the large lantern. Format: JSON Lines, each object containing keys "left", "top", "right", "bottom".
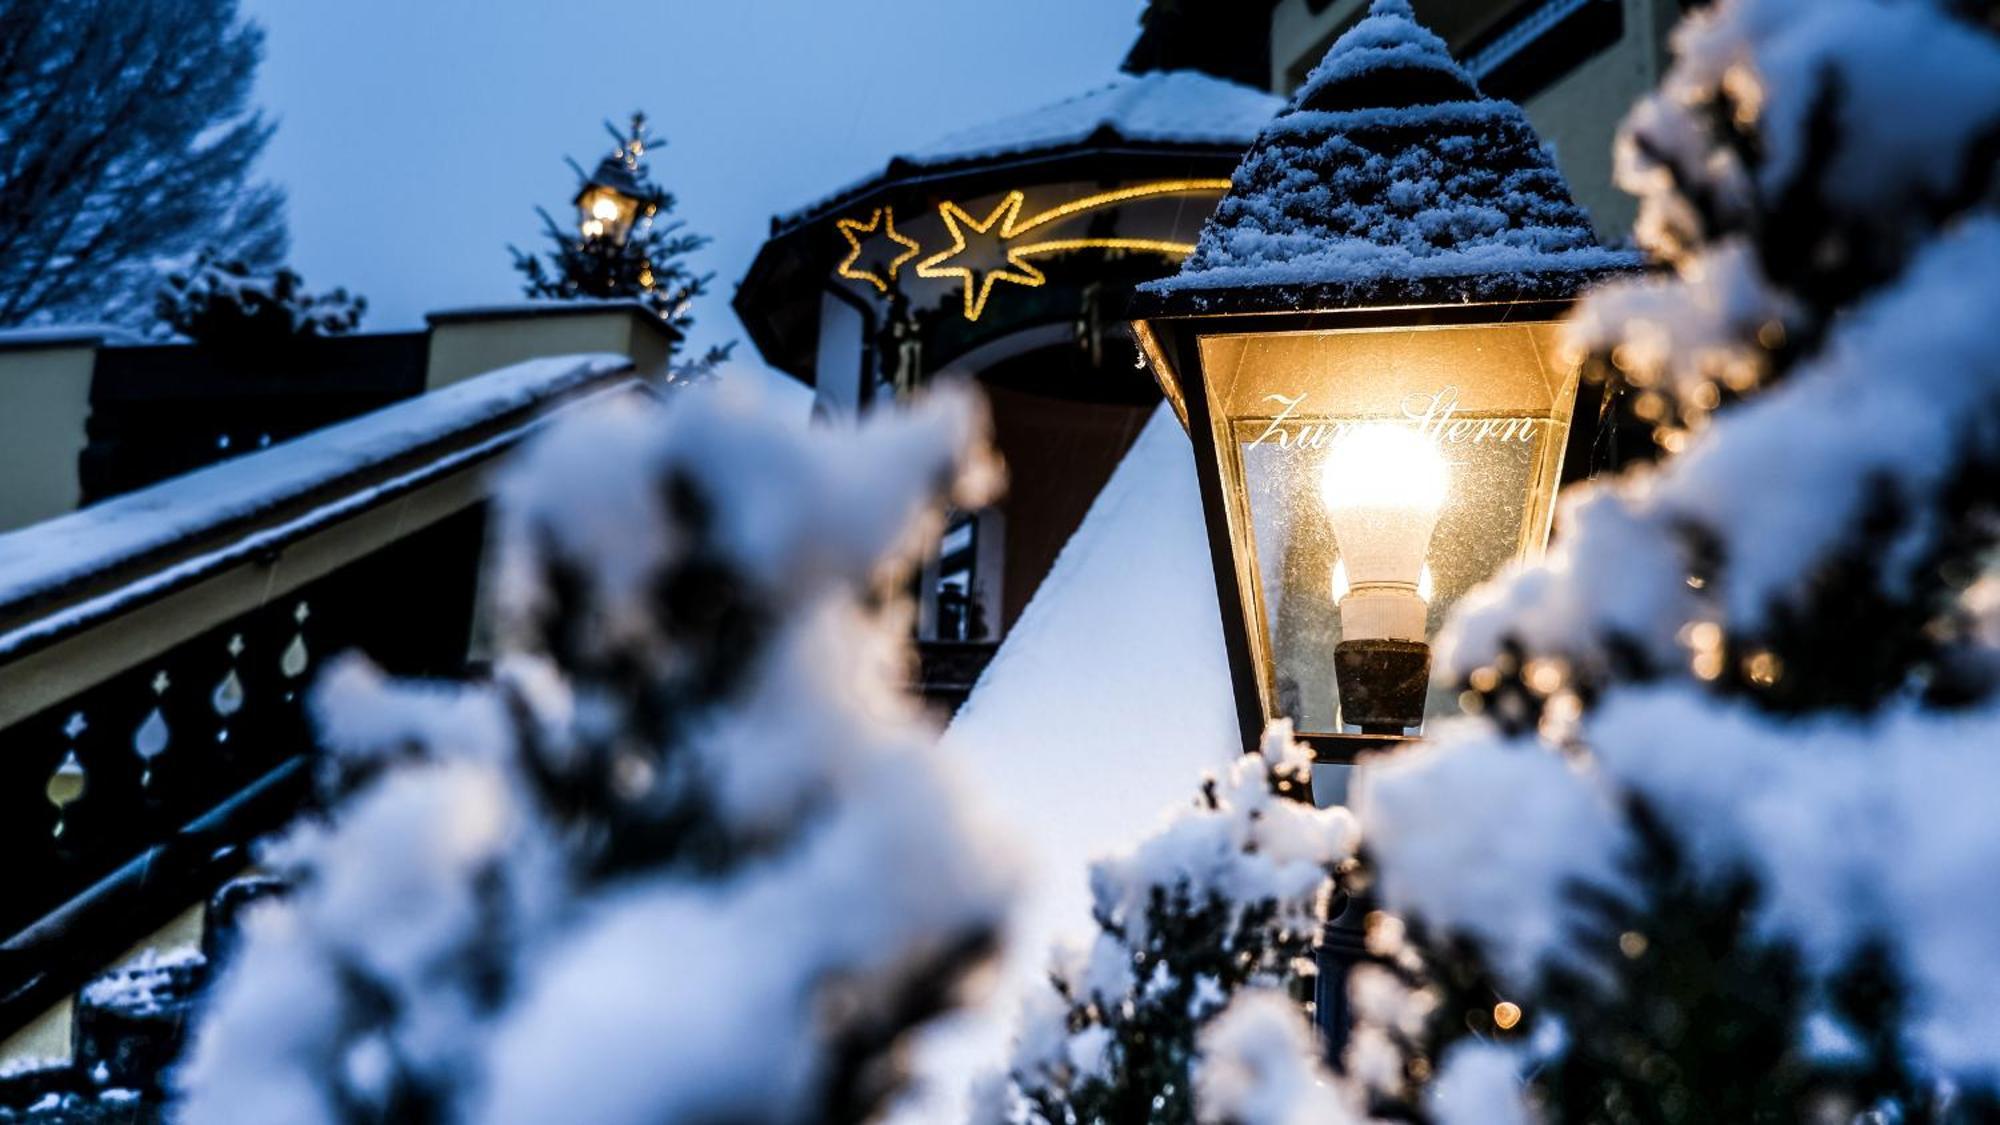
{"left": 182, "top": 378, "right": 1010, "bottom": 1125}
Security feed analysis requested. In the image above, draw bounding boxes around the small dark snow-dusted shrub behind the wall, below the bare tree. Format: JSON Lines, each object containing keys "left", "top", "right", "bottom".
{"left": 154, "top": 252, "right": 368, "bottom": 350}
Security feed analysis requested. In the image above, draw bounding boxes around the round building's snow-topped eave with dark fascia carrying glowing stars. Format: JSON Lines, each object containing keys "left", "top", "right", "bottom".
{"left": 734, "top": 70, "right": 1282, "bottom": 402}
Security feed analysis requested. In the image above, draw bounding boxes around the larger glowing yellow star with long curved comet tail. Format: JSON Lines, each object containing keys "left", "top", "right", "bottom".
{"left": 916, "top": 180, "right": 1230, "bottom": 320}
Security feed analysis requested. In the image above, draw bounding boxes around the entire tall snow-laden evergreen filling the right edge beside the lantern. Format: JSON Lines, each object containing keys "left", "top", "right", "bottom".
{"left": 1184, "top": 0, "right": 2000, "bottom": 1123}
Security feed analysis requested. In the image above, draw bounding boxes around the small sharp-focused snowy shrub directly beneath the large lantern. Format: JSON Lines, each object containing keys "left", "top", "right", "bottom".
{"left": 994, "top": 727, "right": 1354, "bottom": 1125}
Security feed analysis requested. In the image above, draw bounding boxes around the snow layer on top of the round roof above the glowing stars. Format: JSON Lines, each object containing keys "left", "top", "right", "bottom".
{"left": 778, "top": 70, "right": 1284, "bottom": 226}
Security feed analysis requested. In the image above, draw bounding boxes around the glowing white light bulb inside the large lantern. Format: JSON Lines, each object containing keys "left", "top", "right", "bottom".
{"left": 1320, "top": 422, "right": 1452, "bottom": 641}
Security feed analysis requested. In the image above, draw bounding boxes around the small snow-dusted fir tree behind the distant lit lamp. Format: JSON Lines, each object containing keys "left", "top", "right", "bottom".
{"left": 508, "top": 114, "right": 734, "bottom": 378}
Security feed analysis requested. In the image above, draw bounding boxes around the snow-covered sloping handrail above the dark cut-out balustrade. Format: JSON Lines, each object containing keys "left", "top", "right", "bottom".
{"left": 0, "top": 354, "right": 632, "bottom": 661}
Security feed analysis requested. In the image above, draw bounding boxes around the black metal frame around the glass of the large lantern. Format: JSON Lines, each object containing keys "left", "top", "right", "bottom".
{"left": 1132, "top": 294, "right": 1602, "bottom": 765}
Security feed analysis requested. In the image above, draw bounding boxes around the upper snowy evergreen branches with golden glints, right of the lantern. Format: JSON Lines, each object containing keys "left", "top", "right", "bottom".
{"left": 1446, "top": 0, "right": 2000, "bottom": 709}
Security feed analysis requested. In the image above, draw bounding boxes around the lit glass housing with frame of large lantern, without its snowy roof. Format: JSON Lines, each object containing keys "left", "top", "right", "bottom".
{"left": 1136, "top": 300, "right": 1578, "bottom": 745}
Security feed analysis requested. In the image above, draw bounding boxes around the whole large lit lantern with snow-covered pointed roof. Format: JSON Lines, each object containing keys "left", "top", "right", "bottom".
{"left": 1134, "top": 0, "right": 1634, "bottom": 761}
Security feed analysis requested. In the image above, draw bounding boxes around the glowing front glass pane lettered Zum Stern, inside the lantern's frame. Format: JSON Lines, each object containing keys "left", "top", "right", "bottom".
{"left": 1196, "top": 322, "right": 1576, "bottom": 735}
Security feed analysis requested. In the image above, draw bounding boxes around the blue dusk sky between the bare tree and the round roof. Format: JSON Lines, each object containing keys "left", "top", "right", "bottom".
{"left": 244, "top": 0, "right": 1140, "bottom": 362}
